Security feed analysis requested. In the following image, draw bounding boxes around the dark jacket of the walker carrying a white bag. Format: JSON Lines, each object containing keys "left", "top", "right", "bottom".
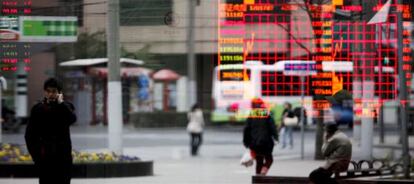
{"left": 243, "top": 115, "right": 278, "bottom": 155}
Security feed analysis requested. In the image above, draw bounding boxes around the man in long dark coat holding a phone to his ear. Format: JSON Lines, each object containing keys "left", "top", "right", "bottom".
{"left": 25, "top": 78, "right": 76, "bottom": 184}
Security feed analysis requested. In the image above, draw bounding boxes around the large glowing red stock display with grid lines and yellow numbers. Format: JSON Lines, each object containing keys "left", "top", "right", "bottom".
{"left": 217, "top": 0, "right": 413, "bottom": 116}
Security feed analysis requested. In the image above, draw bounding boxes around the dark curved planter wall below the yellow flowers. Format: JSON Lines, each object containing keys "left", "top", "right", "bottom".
{"left": 0, "top": 161, "right": 154, "bottom": 178}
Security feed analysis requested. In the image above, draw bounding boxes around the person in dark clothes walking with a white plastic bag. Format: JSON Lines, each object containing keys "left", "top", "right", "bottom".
{"left": 243, "top": 99, "right": 278, "bottom": 175}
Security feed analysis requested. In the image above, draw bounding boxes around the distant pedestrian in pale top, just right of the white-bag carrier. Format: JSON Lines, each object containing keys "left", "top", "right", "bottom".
{"left": 280, "top": 102, "right": 299, "bottom": 149}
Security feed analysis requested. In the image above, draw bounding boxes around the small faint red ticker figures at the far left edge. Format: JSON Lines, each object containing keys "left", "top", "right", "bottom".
{"left": 0, "top": 0, "right": 32, "bottom": 72}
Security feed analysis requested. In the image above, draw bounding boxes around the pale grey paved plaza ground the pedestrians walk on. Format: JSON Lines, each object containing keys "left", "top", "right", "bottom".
{"left": 0, "top": 126, "right": 414, "bottom": 184}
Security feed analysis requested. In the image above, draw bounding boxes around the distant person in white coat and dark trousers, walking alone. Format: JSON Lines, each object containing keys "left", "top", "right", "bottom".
{"left": 187, "top": 104, "right": 204, "bottom": 156}
